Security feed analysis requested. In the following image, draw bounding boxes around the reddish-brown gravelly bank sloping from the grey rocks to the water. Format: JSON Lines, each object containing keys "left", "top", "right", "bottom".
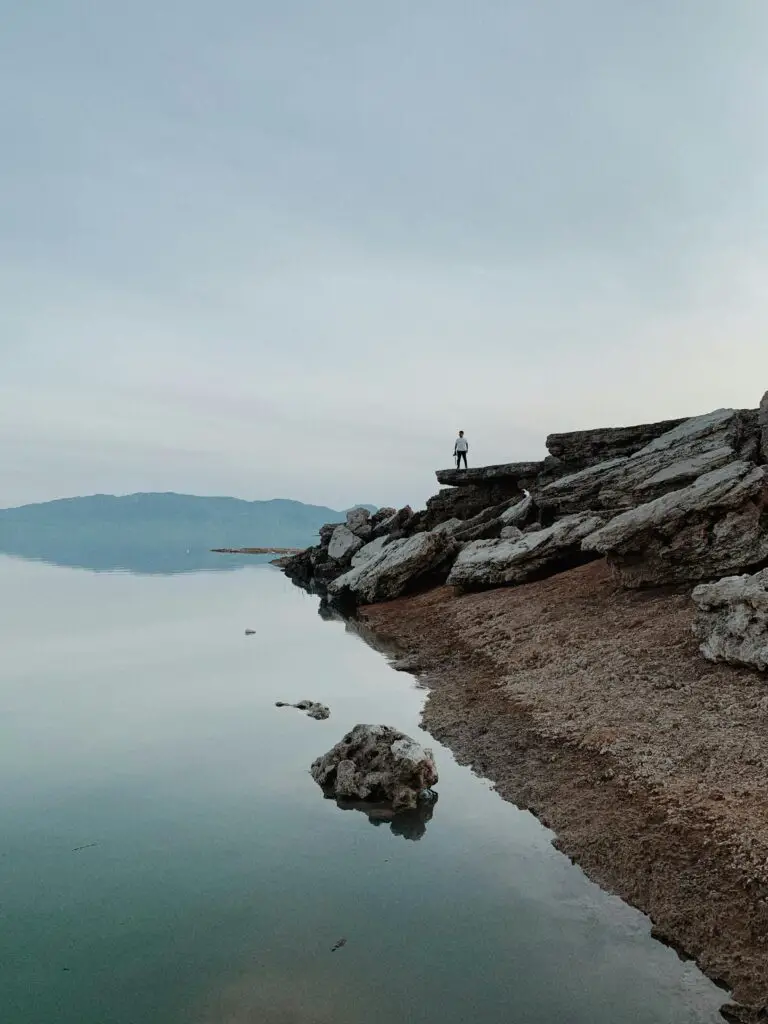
{"left": 362, "top": 562, "right": 768, "bottom": 1020}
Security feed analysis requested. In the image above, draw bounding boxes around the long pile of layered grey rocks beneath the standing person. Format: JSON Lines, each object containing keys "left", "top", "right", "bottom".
{"left": 285, "top": 395, "right": 768, "bottom": 603}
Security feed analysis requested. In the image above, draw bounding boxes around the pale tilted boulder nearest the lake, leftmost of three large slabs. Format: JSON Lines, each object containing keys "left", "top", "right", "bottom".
{"left": 328, "top": 532, "right": 459, "bottom": 604}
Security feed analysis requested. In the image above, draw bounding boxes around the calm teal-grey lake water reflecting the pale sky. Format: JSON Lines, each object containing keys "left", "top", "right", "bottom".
{"left": 0, "top": 556, "right": 726, "bottom": 1024}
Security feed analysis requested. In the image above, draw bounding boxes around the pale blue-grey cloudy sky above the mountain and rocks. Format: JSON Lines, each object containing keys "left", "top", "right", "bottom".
{"left": 0, "top": 0, "right": 768, "bottom": 508}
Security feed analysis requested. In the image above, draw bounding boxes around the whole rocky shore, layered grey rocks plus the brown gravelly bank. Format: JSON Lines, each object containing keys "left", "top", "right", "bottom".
{"left": 284, "top": 395, "right": 768, "bottom": 1021}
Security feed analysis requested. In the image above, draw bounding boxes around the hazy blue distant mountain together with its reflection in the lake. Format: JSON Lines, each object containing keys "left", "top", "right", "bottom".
{"left": 0, "top": 493, "right": 375, "bottom": 572}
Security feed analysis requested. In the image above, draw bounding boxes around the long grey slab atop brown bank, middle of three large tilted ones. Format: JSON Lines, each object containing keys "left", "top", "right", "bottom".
{"left": 447, "top": 512, "right": 604, "bottom": 590}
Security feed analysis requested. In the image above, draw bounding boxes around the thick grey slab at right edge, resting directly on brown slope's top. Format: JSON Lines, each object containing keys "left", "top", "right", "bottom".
{"left": 584, "top": 461, "right": 768, "bottom": 588}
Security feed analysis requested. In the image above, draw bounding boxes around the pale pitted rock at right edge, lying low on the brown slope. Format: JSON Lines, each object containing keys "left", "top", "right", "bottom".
{"left": 692, "top": 569, "right": 768, "bottom": 672}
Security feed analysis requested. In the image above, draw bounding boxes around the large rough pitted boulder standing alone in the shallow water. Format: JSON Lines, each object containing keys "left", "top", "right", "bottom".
{"left": 310, "top": 725, "right": 437, "bottom": 811}
